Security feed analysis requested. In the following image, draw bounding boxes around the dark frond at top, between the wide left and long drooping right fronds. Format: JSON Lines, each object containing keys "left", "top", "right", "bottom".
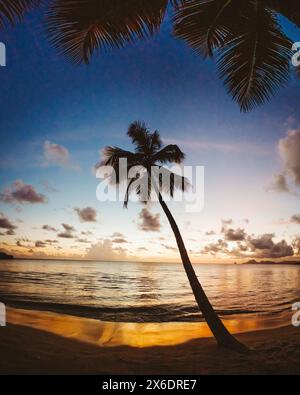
{"left": 174, "top": 0, "right": 242, "bottom": 57}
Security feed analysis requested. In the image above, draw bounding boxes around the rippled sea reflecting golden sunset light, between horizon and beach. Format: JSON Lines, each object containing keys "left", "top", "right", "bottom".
{"left": 0, "top": 260, "right": 300, "bottom": 322}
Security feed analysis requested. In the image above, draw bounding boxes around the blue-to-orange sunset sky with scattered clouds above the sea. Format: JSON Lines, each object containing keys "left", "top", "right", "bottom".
{"left": 0, "top": 6, "right": 300, "bottom": 263}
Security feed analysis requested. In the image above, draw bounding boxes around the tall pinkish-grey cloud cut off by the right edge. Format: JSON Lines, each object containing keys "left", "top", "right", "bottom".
{"left": 278, "top": 130, "right": 300, "bottom": 186}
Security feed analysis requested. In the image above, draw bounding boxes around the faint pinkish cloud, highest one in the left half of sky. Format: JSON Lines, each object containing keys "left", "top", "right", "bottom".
{"left": 44, "top": 141, "right": 78, "bottom": 169}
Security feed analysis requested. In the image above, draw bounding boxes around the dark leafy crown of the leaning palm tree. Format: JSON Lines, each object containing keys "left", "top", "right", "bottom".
{"left": 97, "top": 121, "right": 189, "bottom": 207}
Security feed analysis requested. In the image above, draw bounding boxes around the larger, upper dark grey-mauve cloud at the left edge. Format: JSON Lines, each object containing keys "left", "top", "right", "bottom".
{"left": 0, "top": 180, "right": 47, "bottom": 204}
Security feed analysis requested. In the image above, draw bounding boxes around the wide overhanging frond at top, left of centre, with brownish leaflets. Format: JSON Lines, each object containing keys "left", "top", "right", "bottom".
{"left": 47, "top": 0, "right": 169, "bottom": 63}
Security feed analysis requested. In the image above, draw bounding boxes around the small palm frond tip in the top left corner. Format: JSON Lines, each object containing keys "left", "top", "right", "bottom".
{"left": 0, "top": 0, "right": 41, "bottom": 28}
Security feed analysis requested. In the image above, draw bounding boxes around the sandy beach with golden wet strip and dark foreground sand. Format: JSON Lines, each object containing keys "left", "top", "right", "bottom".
{"left": 0, "top": 308, "right": 300, "bottom": 374}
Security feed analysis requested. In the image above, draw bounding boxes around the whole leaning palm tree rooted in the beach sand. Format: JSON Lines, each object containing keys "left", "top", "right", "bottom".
{"left": 98, "top": 122, "right": 247, "bottom": 352}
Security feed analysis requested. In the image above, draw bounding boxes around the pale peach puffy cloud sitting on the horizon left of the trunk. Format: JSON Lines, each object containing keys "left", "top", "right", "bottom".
{"left": 86, "top": 239, "right": 127, "bottom": 261}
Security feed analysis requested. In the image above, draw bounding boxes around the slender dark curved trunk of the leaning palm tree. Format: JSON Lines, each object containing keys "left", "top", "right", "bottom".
{"left": 158, "top": 192, "right": 248, "bottom": 352}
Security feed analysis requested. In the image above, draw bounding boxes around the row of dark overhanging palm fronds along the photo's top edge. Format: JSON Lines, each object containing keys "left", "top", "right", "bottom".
{"left": 0, "top": 0, "right": 300, "bottom": 112}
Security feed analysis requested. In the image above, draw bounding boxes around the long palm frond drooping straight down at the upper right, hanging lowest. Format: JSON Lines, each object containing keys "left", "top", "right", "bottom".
{"left": 218, "top": 1, "right": 292, "bottom": 112}
